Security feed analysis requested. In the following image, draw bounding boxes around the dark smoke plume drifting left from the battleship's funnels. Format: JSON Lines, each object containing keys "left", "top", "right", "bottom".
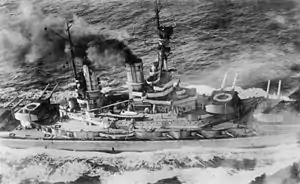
{"left": 0, "top": 2, "right": 140, "bottom": 69}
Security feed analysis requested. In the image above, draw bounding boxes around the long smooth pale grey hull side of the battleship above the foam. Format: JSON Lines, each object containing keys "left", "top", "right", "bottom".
{"left": 0, "top": 133, "right": 300, "bottom": 153}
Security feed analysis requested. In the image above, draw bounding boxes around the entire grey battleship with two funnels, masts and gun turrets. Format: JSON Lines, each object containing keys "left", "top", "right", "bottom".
{"left": 0, "top": 0, "right": 300, "bottom": 153}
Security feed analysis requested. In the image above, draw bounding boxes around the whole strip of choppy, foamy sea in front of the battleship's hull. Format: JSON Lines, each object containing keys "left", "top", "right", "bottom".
{"left": 0, "top": 145, "right": 300, "bottom": 184}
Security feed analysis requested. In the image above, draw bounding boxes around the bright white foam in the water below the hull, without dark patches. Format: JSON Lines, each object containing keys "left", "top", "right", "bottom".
{"left": 0, "top": 145, "right": 300, "bottom": 184}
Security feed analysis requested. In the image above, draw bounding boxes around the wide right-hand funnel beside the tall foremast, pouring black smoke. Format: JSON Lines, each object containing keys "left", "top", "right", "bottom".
{"left": 125, "top": 59, "right": 144, "bottom": 99}
